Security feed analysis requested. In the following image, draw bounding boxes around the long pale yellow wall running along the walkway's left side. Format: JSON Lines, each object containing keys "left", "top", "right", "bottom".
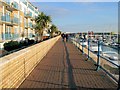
{"left": 0, "top": 36, "right": 60, "bottom": 88}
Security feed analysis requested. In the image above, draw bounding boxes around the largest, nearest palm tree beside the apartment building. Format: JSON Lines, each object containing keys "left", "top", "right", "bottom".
{"left": 35, "top": 12, "right": 52, "bottom": 40}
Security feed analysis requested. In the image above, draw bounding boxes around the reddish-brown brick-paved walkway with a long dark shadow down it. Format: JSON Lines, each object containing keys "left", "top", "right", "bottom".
{"left": 19, "top": 39, "right": 117, "bottom": 90}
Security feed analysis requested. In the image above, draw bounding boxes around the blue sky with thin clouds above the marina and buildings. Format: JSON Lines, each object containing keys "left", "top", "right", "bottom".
{"left": 31, "top": 0, "right": 118, "bottom": 32}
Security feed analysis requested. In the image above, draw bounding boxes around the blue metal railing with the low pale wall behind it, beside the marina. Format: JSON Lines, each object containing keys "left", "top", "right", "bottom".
{"left": 70, "top": 38, "right": 120, "bottom": 88}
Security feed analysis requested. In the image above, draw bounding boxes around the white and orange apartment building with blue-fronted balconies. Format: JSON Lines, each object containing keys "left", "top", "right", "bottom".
{"left": 0, "top": 0, "right": 39, "bottom": 48}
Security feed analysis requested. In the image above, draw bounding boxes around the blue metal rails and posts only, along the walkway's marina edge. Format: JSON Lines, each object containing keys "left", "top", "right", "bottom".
{"left": 70, "top": 38, "right": 120, "bottom": 87}
